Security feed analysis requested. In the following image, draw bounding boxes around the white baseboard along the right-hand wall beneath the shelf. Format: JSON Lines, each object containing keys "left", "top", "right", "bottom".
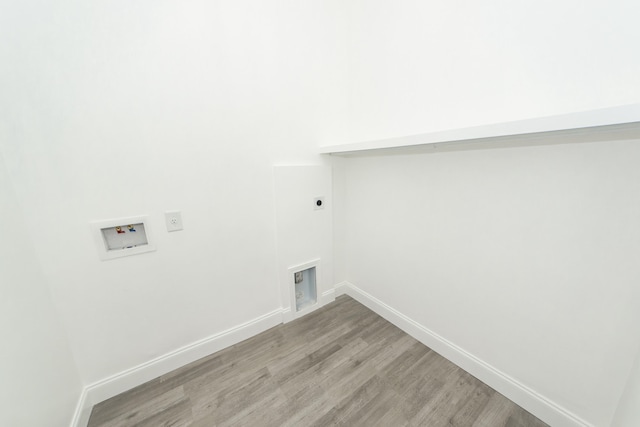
{"left": 335, "top": 282, "right": 593, "bottom": 427}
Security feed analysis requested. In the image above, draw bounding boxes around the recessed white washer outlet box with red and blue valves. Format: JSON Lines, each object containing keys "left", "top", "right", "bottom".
{"left": 91, "top": 216, "right": 156, "bottom": 260}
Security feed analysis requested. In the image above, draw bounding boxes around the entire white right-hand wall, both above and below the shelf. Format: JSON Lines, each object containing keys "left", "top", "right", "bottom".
{"left": 342, "top": 0, "right": 640, "bottom": 426}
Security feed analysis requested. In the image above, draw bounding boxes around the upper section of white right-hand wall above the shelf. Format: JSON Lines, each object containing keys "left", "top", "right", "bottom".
{"left": 342, "top": 0, "right": 640, "bottom": 145}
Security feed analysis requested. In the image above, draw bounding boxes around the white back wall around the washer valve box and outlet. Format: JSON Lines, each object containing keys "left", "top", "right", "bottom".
{"left": 0, "top": 0, "right": 346, "bottom": 384}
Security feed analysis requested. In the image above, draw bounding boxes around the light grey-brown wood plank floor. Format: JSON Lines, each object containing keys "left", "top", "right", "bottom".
{"left": 89, "top": 296, "right": 546, "bottom": 427}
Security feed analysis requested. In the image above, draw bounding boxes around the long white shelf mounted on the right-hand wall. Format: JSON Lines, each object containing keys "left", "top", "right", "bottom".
{"left": 320, "top": 104, "right": 640, "bottom": 154}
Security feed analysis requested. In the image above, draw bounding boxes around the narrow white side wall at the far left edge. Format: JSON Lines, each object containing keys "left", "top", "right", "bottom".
{"left": 0, "top": 156, "right": 82, "bottom": 427}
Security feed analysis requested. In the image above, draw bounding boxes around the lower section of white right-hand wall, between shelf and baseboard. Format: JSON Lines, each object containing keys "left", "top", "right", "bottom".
{"left": 343, "top": 140, "right": 640, "bottom": 426}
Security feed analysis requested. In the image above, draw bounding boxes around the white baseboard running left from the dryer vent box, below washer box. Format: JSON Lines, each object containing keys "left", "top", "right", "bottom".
{"left": 71, "top": 309, "right": 283, "bottom": 427}
